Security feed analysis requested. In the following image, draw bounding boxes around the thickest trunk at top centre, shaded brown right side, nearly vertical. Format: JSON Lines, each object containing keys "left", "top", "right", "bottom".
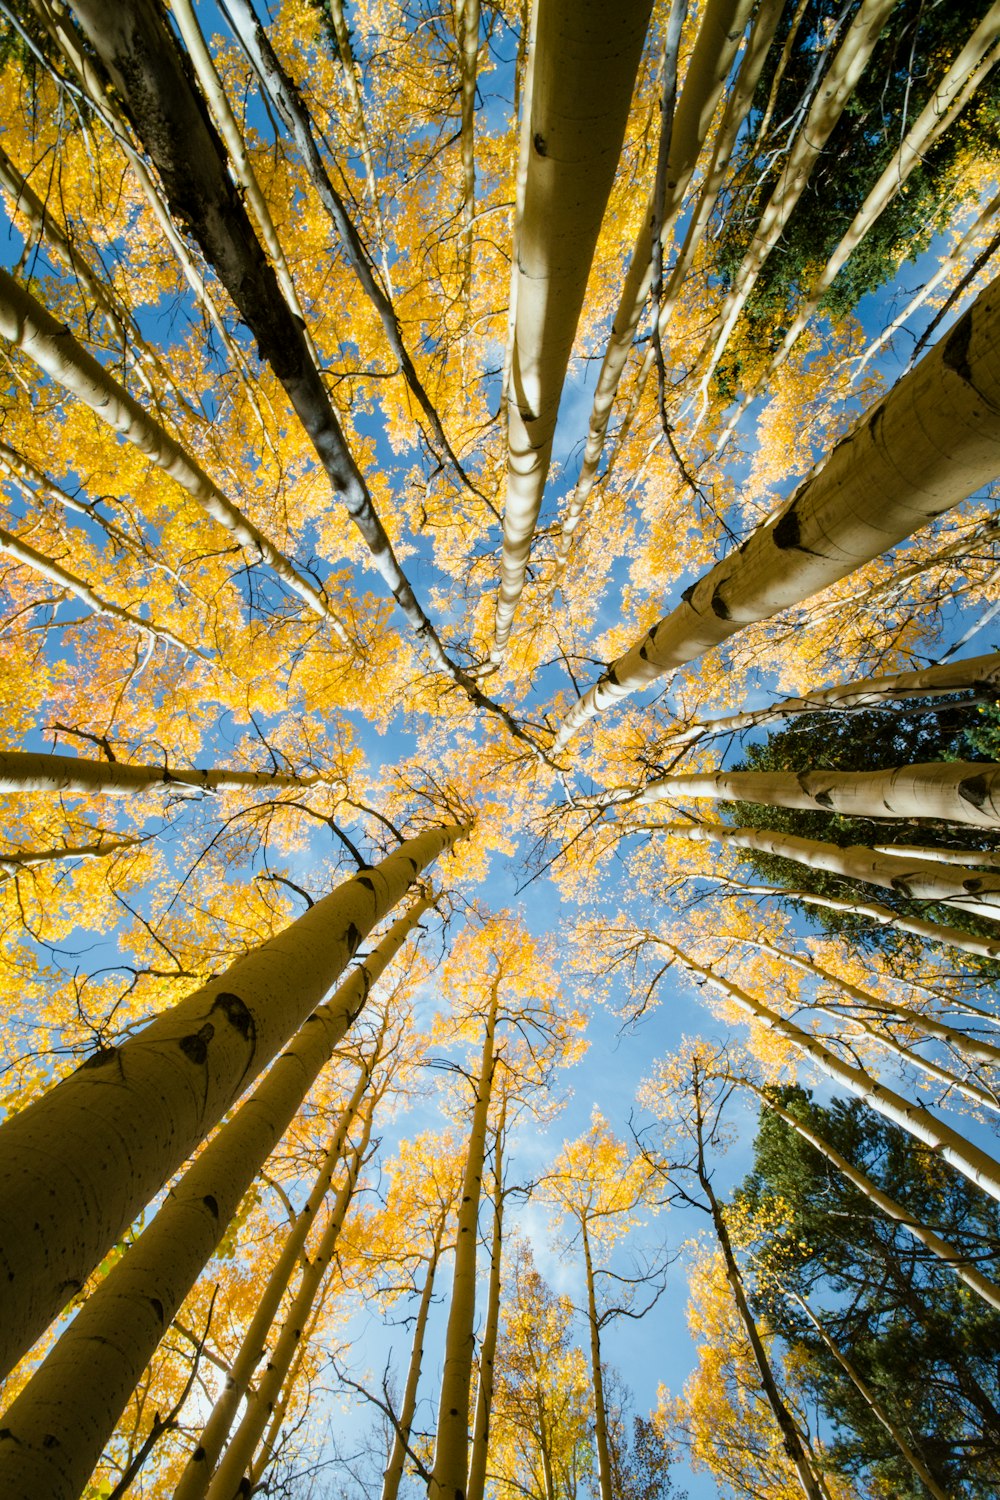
{"left": 492, "top": 0, "right": 651, "bottom": 665}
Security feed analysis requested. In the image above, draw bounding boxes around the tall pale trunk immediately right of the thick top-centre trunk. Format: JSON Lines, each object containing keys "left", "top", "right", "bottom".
{"left": 556, "top": 0, "right": 753, "bottom": 576}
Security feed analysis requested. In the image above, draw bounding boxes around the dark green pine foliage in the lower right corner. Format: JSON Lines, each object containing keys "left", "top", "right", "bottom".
{"left": 738, "top": 1088, "right": 1000, "bottom": 1500}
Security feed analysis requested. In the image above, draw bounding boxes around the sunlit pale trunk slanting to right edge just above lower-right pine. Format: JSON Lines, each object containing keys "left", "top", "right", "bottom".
{"left": 660, "top": 939, "right": 1000, "bottom": 1200}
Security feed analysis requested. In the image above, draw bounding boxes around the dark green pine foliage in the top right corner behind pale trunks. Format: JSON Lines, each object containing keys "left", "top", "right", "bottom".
{"left": 717, "top": 0, "right": 1000, "bottom": 398}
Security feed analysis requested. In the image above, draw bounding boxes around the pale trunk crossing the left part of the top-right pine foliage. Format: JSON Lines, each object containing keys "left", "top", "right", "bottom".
{"left": 700, "top": 0, "right": 895, "bottom": 414}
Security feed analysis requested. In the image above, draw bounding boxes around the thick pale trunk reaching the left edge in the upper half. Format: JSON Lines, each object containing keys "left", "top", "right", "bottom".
{"left": 0, "top": 267, "right": 346, "bottom": 641}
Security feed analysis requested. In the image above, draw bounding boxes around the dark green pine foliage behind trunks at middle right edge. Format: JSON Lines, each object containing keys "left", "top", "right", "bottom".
{"left": 718, "top": 698, "right": 1000, "bottom": 978}
